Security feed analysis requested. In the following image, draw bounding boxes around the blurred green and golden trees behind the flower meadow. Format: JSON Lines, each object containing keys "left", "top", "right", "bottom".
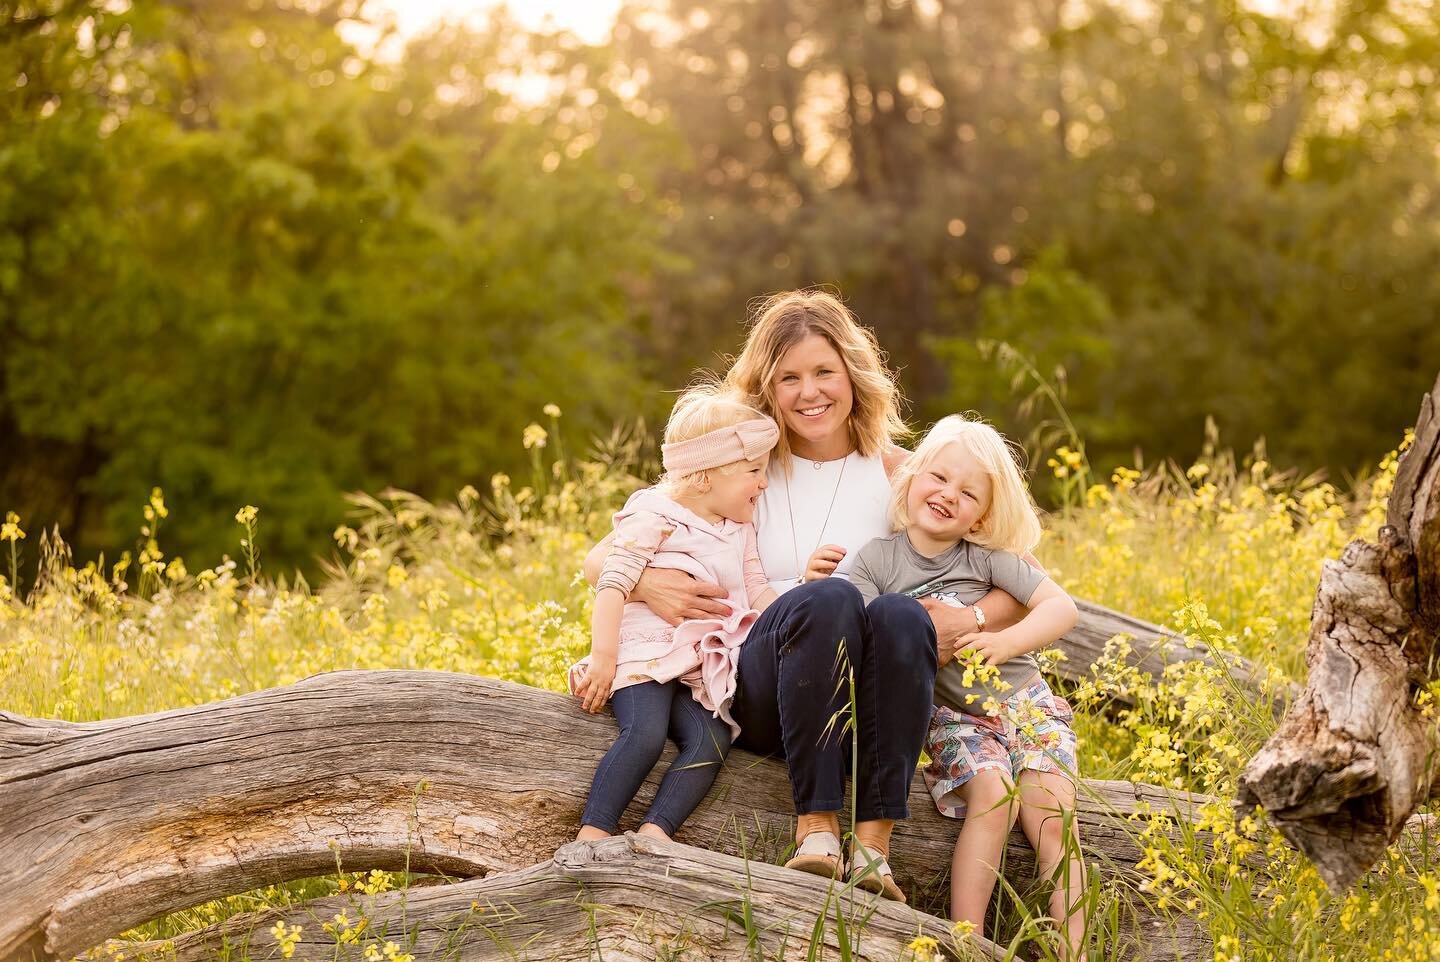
{"left": 0, "top": 0, "right": 1440, "bottom": 565}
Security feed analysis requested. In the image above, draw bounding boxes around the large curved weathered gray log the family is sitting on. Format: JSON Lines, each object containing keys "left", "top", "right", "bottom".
{"left": 0, "top": 671, "right": 1208, "bottom": 962}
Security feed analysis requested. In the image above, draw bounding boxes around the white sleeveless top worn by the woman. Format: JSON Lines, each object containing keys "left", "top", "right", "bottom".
{"left": 755, "top": 452, "right": 890, "bottom": 593}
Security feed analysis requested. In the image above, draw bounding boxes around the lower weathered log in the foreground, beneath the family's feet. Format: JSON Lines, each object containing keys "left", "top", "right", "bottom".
{"left": 124, "top": 835, "right": 1005, "bottom": 962}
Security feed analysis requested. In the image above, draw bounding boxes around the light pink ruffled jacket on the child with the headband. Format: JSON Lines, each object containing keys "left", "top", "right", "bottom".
{"left": 570, "top": 488, "right": 769, "bottom": 736}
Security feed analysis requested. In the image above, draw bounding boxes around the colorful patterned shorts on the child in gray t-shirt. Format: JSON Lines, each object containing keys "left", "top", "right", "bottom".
{"left": 924, "top": 680, "right": 1076, "bottom": 818}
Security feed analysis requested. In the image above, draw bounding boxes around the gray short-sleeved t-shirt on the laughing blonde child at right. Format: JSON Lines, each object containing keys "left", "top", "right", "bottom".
{"left": 850, "top": 531, "right": 1045, "bottom": 714}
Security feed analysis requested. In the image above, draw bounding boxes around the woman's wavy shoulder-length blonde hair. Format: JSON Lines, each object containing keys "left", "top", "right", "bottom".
{"left": 726, "top": 291, "right": 909, "bottom": 471}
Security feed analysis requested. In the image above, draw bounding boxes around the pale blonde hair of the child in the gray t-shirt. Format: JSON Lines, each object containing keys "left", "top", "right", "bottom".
{"left": 890, "top": 415, "right": 1040, "bottom": 554}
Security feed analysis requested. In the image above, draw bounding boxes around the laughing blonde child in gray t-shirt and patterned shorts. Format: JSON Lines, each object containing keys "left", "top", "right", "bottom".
{"left": 850, "top": 415, "right": 1084, "bottom": 958}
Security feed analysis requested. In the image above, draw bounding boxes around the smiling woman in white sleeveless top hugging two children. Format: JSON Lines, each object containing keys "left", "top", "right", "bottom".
{"left": 586, "top": 291, "right": 1024, "bottom": 902}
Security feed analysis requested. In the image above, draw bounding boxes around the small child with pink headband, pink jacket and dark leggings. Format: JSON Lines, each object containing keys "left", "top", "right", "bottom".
{"left": 570, "top": 386, "right": 779, "bottom": 840}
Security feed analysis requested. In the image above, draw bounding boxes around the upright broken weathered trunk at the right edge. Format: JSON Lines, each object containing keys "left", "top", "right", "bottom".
{"left": 1237, "top": 371, "right": 1440, "bottom": 891}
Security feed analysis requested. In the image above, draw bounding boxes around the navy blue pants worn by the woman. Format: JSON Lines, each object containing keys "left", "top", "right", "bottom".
{"left": 733, "top": 577, "right": 937, "bottom": 821}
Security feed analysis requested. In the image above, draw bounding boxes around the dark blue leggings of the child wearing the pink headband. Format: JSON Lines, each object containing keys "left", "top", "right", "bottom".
{"left": 580, "top": 681, "right": 730, "bottom": 835}
